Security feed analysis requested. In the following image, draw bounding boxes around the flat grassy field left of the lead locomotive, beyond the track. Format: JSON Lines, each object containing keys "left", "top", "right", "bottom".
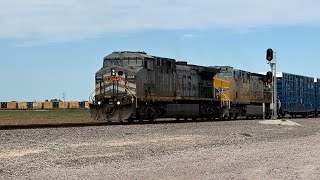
{"left": 0, "top": 110, "right": 93, "bottom": 125}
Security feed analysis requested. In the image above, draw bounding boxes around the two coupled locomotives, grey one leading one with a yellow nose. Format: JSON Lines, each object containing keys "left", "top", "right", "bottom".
{"left": 90, "top": 51, "right": 272, "bottom": 122}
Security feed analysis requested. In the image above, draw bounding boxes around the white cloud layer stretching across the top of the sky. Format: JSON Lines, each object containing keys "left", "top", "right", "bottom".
{"left": 0, "top": 0, "right": 320, "bottom": 44}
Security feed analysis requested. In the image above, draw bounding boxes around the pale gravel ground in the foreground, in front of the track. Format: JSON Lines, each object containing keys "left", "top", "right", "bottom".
{"left": 0, "top": 119, "right": 320, "bottom": 179}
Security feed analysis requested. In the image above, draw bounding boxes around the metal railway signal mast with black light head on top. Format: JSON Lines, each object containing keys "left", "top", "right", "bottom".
{"left": 267, "top": 49, "right": 278, "bottom": 119}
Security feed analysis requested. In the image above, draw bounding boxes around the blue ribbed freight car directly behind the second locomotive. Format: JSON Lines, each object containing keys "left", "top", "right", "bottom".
{"left": 277, "top": 73, "right": 317, "bottom": 115}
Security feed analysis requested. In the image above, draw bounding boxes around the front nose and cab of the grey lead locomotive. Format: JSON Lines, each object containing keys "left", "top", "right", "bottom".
{"left": 90, "top": 51, "right": 153, "bottom": 121}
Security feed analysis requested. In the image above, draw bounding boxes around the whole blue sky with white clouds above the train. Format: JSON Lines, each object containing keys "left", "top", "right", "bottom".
{"left": 0, "top": 0, "right": 320, "bottom": 101}
